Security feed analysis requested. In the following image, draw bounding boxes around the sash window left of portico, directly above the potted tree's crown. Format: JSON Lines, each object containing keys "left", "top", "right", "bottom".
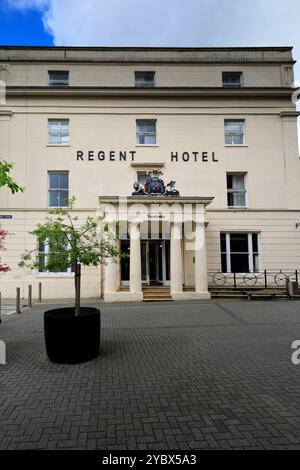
{"left": 48, "top": 171, "right": 69, "bottom": 207}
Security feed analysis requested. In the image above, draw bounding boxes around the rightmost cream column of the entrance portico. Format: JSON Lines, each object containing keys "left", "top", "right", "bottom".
{"left": 195, "top": 220, "right": 210, "bottom": 298}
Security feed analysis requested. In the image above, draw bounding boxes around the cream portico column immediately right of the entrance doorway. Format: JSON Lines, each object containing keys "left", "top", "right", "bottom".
{"left": 170, "top": 222, "right": 182, "bottom": 298}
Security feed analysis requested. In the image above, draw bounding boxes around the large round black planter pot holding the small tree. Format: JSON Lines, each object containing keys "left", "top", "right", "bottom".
{"left": 44, "top": 307, "right": 100, "bottom": 364}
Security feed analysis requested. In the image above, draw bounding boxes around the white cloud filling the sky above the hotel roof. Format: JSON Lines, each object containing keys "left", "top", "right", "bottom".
{"left": 6, "top": 0, "right": 300, "bottom": 54}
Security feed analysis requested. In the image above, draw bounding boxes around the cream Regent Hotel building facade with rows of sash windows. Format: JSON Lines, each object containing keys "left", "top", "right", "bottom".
{"left": 0, "top": 47, "right": 300, "bottom": 301}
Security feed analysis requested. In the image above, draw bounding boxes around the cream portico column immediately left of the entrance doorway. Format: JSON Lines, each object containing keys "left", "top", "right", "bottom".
{"left": 129, "top": 223, "right": 142, "bottom": 300}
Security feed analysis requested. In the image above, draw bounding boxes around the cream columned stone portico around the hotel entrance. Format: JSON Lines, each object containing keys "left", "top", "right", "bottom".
{"left": 99, "top": 196, "right": 213, "bottom": 302}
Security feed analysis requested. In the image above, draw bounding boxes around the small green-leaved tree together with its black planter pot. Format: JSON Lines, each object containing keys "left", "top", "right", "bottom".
{"left": 19, "top": 198, "right": 121, "bottom": 363}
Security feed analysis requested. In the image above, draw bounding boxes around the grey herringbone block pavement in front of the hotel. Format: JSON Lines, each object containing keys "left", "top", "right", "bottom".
{"left": 0, "top": 300, "right": 300, "bottom": 450}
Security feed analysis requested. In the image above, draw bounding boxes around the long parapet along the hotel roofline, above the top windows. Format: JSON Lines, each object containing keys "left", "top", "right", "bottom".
{"left": 0, "top": 46, "right": 294, "bottom": 64}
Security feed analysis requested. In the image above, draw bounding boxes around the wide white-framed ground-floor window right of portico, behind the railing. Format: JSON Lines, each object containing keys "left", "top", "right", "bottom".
{"left": 220, "top": 233, "right": 259, "bottom": 273}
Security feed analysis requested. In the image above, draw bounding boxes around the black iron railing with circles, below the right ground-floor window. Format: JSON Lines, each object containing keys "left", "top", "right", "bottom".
{"left": 208, "top": 269, "right": 299, "bottom": 288}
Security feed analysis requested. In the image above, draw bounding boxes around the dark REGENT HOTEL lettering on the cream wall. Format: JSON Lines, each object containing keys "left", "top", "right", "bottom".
{"left": 76, "top": 150, "right": 219, "bottom": 163}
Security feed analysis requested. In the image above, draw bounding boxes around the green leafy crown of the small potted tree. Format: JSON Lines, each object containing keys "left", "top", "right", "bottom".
{"left": 19, "top": 197, "right": 125, "bottom": 272}
